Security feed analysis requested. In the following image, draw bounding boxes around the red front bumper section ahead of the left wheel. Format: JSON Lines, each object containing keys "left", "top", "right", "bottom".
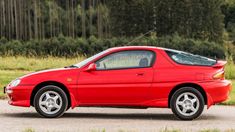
{"left": 4, "top": 86, "right": 33, "bottom": 107}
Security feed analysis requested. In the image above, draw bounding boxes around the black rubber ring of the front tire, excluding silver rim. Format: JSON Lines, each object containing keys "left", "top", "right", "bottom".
{"left": 34, "top": 85, "right": 68, "bottom": 118}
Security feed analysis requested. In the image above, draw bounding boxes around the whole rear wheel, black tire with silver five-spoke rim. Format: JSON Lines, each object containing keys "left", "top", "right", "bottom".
{"left": 170, "top": 87, "right": 205, "bottom": 120}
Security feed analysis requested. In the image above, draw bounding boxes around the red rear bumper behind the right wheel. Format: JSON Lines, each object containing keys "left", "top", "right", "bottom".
{"left": 200, "top": 80, "right": 232, "bottom": 108}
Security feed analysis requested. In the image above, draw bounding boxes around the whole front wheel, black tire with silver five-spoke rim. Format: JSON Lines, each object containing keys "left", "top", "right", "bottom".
{"left": 34, "top": 85, "right": 68, "bottom": 118}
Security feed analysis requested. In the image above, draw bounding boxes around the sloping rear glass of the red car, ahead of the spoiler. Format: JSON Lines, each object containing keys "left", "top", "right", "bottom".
{"left": 165, "top": 50, "right": 216, "bottom": 66}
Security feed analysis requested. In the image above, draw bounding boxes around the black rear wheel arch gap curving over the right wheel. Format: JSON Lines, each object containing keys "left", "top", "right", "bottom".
{"left": 168, "top": 83, "right": 207, "bottom": 108}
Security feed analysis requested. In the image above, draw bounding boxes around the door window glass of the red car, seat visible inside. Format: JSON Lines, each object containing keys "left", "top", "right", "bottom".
{"left": 96, "top": 50, "right": 155, "bottom": 70}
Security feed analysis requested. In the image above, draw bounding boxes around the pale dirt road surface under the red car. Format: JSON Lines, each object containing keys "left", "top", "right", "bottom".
{"left": 0, "top": 100, "right": 235, "bottom": 132}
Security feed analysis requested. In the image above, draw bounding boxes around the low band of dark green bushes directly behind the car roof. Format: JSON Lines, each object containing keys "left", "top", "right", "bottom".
{"left": 0, "top": 35, "right": 225, "bottom": 58}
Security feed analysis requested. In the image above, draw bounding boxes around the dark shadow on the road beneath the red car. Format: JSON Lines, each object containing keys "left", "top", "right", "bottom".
{"left": 1, "top": 112, "right": 216, "bottom": 121}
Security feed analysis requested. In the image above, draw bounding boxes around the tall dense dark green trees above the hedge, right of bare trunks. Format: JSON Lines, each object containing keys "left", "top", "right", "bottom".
{"left": 108, "top": 0, "right": 224, "bottom": 42}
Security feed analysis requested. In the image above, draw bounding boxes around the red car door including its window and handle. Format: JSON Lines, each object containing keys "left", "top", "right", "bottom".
{"left": 78, "top": 50, "right": 155, "bottom": 105}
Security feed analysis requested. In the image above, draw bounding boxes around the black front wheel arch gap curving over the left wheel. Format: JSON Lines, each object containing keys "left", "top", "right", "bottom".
{"left": 30, "top": 81, "right": 71, "bottom": 108}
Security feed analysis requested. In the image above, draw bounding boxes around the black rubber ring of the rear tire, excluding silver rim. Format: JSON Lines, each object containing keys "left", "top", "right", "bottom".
{"left": 170, "top": 87, "right": 205, "bottom": 120}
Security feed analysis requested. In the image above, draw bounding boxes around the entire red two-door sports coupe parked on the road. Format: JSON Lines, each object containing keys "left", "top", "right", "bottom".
{"left": 4, "top": 46, "right": 231, "bottom": 120}
